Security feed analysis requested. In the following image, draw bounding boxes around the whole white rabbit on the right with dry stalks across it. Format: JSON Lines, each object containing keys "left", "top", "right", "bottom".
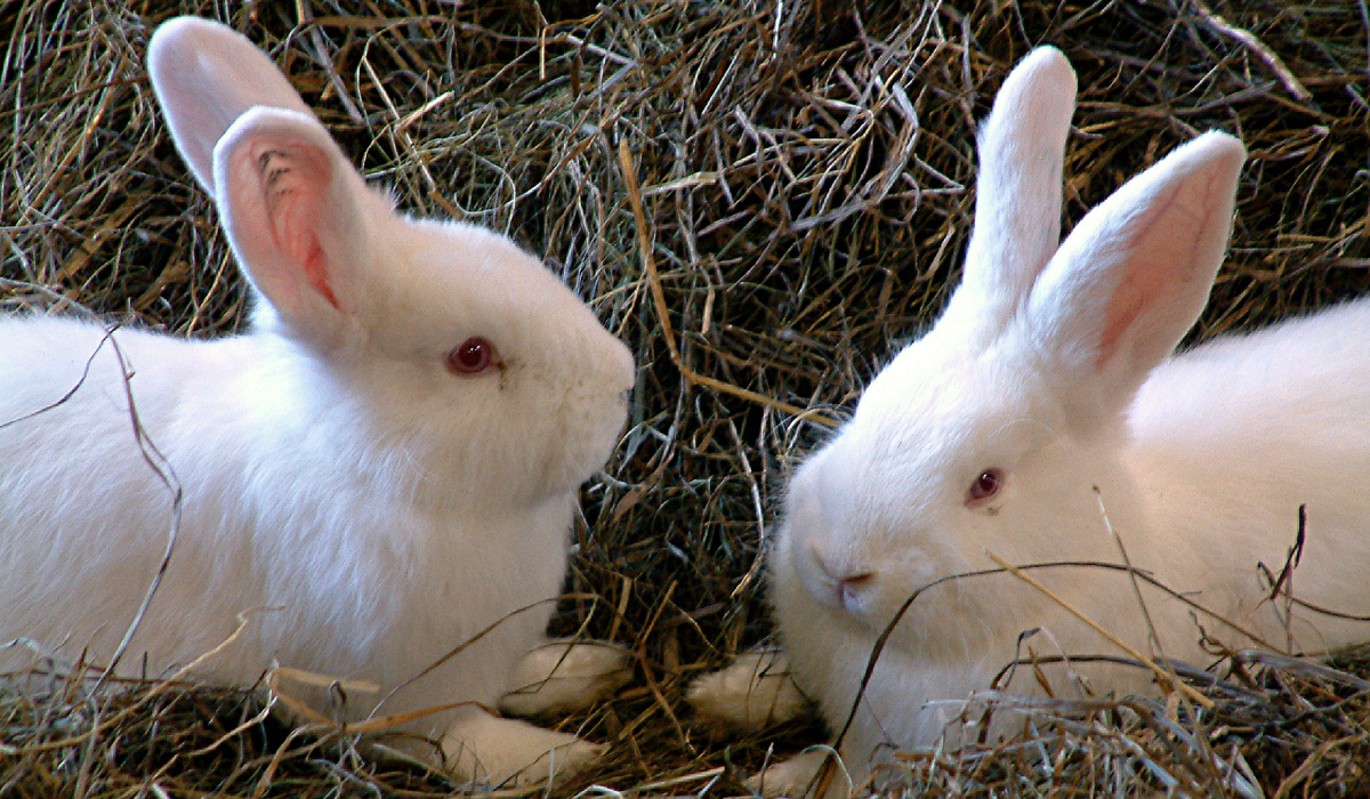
{"left": 693, "top": 48, "right": 1370, "bottom": 792}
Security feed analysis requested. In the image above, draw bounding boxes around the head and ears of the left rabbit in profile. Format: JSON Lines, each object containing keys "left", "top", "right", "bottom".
{"left": 148, "top": 18, "right": 634, "bottom": 504}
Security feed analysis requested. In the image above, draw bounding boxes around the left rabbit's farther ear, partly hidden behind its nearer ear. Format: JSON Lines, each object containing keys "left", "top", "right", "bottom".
{"left": 148, "top": 16, "right": 311, "bottom": 195}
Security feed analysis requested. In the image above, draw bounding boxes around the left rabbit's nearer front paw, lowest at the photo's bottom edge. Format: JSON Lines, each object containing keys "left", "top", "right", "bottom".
{"left": 443, "top": 710, "right": 607, "bottom": 787}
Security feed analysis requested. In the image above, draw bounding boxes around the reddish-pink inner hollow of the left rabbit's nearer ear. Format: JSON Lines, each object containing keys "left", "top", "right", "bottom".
{"left": 253, "top": 147, "right": 338, "bottom": 308}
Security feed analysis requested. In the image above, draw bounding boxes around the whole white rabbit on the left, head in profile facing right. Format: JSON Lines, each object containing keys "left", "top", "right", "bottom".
{"left": 0, "top": 18, "right": 634, "bottom": 781}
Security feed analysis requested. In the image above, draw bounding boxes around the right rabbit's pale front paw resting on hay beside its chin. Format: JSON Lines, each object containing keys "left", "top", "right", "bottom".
{"left": 685, "top": 651, "right": 810, "bottom": 730}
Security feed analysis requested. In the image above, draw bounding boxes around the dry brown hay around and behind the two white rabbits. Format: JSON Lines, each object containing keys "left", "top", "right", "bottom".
{"left": 0, "top": 0, "right": 1370, "bottom": 796}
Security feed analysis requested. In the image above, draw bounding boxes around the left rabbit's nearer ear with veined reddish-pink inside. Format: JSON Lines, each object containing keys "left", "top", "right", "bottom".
{"left": 214, "top": 108, "right": 378, "bottom": 347}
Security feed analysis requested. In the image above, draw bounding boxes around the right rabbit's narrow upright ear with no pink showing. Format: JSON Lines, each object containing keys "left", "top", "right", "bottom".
{"left": 947, "top": 47, "right": 1075, "bottom": 341}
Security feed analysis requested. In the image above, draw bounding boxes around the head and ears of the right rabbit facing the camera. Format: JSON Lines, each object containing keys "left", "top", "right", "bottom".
{"left": 771, "top": 48, "right": 1245, "bottom": 661}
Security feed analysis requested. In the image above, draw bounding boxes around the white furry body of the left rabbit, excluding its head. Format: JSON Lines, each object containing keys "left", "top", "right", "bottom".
{"left": 0, "top": 318, "right": 574, "bottom": 693}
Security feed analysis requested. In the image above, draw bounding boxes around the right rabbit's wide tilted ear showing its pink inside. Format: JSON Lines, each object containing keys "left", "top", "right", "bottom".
{"left": 1026, "top": 133, "right": 1247, "bottom": 423}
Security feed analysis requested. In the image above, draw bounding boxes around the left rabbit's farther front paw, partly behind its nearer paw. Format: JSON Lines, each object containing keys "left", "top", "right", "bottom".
{"left": 500, "top": 641, "right": 633, "bottom": 717}
